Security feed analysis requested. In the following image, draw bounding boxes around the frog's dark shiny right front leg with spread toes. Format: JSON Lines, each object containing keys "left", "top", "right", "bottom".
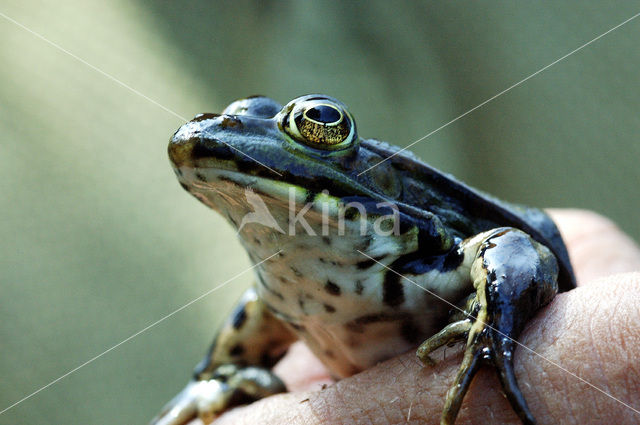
{"left": 417, "top": 228, "right": 558, "bottom": 424}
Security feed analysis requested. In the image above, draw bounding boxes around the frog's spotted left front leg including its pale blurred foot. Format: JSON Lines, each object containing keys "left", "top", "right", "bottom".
{"left": 151, "top": 288, "right": 295, "bottom": 425}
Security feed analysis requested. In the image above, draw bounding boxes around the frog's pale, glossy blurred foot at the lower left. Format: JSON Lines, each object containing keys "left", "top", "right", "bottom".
{"left": 150, "top": 364, "right": 286, "bottom": 425}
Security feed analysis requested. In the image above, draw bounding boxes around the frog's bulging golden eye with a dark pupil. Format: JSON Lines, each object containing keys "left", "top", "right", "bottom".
{"left": 282, "top": 96, "right": 356, "bottom": 150}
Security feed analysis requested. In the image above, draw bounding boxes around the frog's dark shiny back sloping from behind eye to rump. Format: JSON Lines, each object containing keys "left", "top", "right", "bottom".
{"left": 363, "top": 140, "right": 575, "bottom": 291}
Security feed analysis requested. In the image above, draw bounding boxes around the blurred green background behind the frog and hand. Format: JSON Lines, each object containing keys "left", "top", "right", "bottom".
{"left": 0, "top": 0, "right": 640, "bottom": 424}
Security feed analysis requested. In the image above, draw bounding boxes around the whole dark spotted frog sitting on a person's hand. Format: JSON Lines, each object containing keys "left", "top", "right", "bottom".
{"left": 151, "top": 94, "right": 576, "bottom": 425}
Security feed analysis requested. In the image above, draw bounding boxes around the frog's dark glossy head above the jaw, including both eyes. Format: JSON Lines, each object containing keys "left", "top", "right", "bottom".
{"left": 169, "top": 95, "right": 408, "bottom": 198}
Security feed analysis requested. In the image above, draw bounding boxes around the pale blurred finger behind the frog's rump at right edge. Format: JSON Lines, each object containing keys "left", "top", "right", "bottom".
{"left": 548, "top": 209, "right": 640, "bottom": 284}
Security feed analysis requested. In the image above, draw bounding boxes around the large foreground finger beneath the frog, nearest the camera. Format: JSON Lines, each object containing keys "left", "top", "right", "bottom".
{"left": 211, "top": 274, "right": 640, "bottom": 425}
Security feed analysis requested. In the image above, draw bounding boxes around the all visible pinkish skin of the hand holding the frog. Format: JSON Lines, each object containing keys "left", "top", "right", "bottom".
{"left": 190, "top": 210, "right": 640, "bottom": 425}
